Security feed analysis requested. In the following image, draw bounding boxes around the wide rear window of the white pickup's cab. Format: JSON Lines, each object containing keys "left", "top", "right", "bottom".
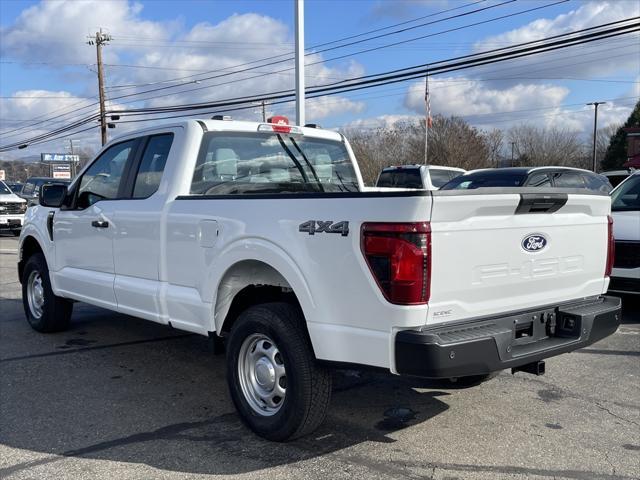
{"left": 191, "top": 132, "right": 358, "bottom": 195}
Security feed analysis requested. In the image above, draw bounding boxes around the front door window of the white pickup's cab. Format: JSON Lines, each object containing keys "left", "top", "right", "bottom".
{"left": 76, "top": 140, "right": 136, "bottom": 209}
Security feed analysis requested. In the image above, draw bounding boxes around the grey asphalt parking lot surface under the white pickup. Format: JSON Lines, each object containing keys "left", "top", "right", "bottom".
{"left": 0, "top": 231, "right": 640, "bottom": 480}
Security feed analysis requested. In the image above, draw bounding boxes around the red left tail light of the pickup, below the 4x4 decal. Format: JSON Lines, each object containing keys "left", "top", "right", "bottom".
{"left": 361, "top": 222, "right": 431, "bottom": 305}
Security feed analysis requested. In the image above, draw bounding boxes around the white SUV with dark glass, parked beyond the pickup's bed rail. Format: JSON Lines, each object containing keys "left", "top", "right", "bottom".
{"left": 376, "top": 165, "right": 465, "bottom": 190}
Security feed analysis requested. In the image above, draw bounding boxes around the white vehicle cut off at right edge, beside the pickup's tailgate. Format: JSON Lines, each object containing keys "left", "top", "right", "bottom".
{"left": 609, "top": 171, "right": 640, "bottom": 295}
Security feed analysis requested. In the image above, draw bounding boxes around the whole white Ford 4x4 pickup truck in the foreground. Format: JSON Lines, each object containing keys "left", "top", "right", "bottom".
{"left": 18, "top": 120, "right": 620, "bottom": 441}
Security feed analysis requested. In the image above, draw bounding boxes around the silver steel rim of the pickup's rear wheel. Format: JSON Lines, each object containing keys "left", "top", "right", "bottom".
{"left": 238, "top": 333, "right": 287, "bottom": 417}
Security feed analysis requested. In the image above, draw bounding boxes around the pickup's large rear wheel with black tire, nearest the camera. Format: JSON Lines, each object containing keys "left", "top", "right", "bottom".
{"left": 227, "top": 303, "right": 331, "bottom": 441}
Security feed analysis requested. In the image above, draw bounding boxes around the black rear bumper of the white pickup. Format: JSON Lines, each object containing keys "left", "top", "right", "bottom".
{"left": 395, "top": 296, "right": 621, "bottom": 378}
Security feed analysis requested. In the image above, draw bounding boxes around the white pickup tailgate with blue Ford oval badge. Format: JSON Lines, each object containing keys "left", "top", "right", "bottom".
{"left": 427, "top": 189, "right": 611, "bottom": 324}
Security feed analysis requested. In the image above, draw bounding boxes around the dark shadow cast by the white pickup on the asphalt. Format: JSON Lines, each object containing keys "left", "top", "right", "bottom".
{"left": 0, "top": 299, "right": 456, "bottom": 478}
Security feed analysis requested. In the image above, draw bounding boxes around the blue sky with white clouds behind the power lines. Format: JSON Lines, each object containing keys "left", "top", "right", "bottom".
{"left": 0, "top": 0, "right": 640, "bottom": 159}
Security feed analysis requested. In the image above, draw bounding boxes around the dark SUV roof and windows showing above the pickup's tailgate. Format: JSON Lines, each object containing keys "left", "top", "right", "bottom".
{"left": 441, "top": 167, "right": 612, "bottom": 193}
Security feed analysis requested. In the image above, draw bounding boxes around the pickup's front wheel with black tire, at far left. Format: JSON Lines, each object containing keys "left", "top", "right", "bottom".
{"left": 22, "top": 253, "right": 73, "bottom": 333}
